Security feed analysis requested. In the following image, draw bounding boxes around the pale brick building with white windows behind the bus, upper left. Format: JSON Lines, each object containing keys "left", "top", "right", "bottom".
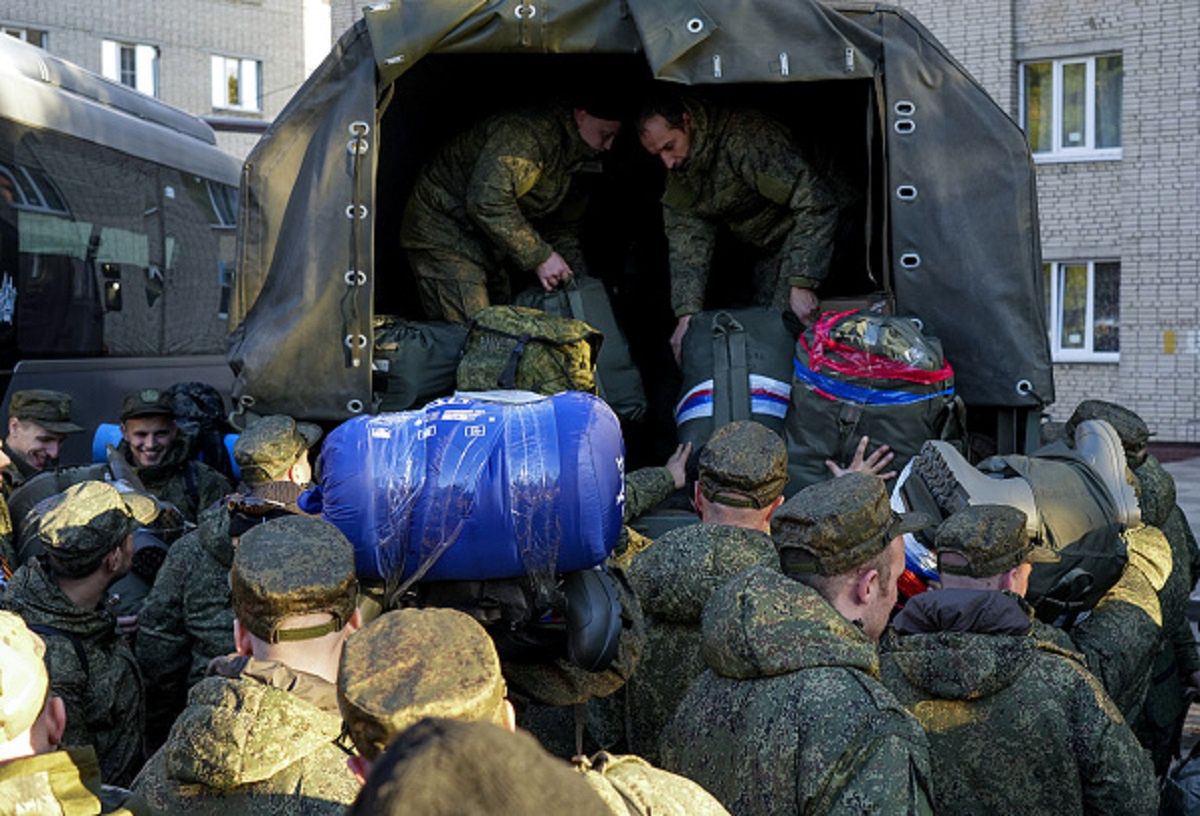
{"left": 0, "top": 0, "right": 316, "bottom": 157}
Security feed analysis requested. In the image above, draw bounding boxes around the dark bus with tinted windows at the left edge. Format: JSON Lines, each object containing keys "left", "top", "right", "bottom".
{"left": 0, "top": 36, "right": 240, "bottom": 461}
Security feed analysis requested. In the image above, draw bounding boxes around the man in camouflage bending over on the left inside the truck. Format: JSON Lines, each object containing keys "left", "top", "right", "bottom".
{"left": 400, "top": 100, "right": 620, "bottom": 323}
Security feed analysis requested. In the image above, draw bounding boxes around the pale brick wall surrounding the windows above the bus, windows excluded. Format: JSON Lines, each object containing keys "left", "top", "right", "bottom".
{"left": 0, "top": 0, "right": 305, "bottom": 157}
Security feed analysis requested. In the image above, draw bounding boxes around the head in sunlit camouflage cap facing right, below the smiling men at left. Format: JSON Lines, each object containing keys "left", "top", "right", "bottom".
{"left": 25, "top": 481, "right": 160, "bottom": 587}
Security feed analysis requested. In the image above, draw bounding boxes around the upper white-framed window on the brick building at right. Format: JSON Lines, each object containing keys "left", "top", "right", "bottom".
{"left": 1020, "top": 54, "right": 1122, "bottom": 161}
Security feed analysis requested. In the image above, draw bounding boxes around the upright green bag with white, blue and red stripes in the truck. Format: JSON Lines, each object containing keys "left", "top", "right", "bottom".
{"left": 676, "top": 308, "right": 796, "bottom": 461}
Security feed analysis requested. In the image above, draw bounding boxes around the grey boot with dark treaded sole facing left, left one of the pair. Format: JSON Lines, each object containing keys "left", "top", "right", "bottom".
{"left": 912, "top": 440, "right": 1042, "bottom": 538}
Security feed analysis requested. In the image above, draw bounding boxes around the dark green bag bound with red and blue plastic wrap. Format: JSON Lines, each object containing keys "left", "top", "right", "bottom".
{"left": 786, "top": 310, "right": 965, "bottom": 496}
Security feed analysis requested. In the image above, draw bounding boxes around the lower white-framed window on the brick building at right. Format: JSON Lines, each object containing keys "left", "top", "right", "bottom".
{"left": 1043, "top": 260, "right": 1121, "bottom": 362}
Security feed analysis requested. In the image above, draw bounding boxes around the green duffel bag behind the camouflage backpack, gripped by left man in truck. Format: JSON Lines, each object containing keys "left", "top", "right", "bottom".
{"left": 512, "top": 277, "right": 646, "bottom": 420}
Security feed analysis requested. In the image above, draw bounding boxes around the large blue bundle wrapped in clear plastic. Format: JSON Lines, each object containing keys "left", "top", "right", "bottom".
{"left": 301, "top": 391, "right": 625, "bottom": 586}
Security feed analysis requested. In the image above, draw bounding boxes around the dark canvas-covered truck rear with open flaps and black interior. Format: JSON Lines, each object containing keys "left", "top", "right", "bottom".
{"left": 230, "top": 0, "right": 1054, "bottom": 451}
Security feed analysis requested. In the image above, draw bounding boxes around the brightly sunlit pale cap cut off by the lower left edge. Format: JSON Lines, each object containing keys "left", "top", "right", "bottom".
{"left": 0, "top": 612, "right": 50, "bottom": 743}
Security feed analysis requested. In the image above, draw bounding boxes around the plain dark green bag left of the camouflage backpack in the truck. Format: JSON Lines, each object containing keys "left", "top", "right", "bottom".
{"left": 373, "top": 317, "right": 467, "bottom": 410}
